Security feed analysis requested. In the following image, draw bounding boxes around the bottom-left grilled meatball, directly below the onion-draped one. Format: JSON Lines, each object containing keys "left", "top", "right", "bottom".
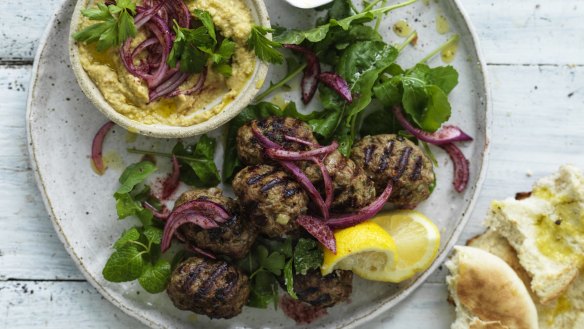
{"left": 166, "top": 257, "right": 250, "bottom": 319}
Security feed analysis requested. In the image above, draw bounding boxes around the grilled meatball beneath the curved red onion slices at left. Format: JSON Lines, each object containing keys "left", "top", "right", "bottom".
{"left": 175, "top": 188, "right": 257, "bottom": 259}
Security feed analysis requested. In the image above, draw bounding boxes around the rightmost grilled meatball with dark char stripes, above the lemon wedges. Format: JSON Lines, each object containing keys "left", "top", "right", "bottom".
{"left": 351, "top": 134, "right": 434, "bottom": 207}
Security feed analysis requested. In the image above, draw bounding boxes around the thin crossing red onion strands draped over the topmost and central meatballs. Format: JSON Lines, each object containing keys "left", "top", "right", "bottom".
{"left": 251, "top": 121, "right": 338, "bottom": 219}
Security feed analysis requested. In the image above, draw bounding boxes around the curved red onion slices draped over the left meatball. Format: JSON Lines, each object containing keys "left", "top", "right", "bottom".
{"left": 160, "top": 200, "right": 232, "bottom": 252}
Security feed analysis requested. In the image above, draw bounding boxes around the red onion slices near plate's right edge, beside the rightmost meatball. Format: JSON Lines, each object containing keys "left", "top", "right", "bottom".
{"left": 393, "top": 106, "right": 473, "bottom": 193}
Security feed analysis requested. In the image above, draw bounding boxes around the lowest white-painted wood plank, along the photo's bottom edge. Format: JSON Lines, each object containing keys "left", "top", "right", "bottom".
{"left": 0, "top": 281, "right": 453, "bottom": 329}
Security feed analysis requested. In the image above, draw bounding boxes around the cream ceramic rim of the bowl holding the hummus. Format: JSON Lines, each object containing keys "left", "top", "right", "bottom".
{"left": 69, "top": 0, "right": 270, "bottom": 138}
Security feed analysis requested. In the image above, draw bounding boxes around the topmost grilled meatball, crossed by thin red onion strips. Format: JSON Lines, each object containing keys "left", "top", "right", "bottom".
{"left": 237, "top": 117, "right": 317, "bottom": 165}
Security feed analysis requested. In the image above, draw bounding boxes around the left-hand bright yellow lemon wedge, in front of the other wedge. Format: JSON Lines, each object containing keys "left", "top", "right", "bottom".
{"left": 321, "top": 221, "right": 397, "bottom": 281}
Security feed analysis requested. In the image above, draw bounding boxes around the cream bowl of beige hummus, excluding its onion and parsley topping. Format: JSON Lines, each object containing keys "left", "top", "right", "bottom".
{"left": 69, "top": 0, "right": 269, "bottom": 138}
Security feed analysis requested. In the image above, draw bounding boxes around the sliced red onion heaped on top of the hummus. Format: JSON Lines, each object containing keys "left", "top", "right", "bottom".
{"left": 120, "top": 0, "right": 207, "bottom": 102}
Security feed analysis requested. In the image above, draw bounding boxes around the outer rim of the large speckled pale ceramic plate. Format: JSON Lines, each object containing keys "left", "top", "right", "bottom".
{"left": 26, "top": 0, "right": 492, "bottom": 328}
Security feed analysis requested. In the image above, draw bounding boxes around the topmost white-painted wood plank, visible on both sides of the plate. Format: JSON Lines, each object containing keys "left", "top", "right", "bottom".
{"left": 0, "top": 0, "right": 584, "bottom": 64}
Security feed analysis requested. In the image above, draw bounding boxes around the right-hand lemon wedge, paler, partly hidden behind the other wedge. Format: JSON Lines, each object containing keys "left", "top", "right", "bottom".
{"left": 371, "top": 210, "right": 440, "bottom": 282}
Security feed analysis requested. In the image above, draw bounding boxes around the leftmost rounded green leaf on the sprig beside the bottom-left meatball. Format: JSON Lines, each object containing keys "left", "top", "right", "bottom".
{"left": 102, "top": 244, "right": 144, "bottom": 282}
